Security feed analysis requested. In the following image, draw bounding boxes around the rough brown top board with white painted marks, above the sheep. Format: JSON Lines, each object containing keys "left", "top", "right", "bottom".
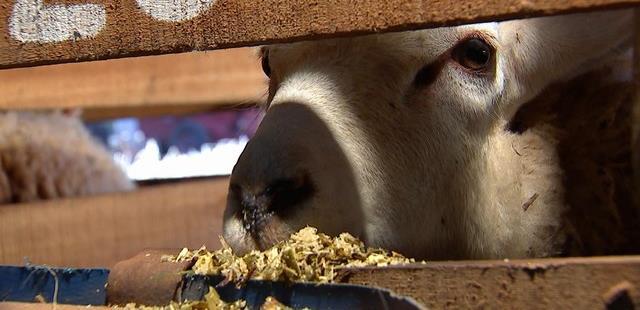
{"left": 0, "top": 0, "right": 640, "bottom": 68}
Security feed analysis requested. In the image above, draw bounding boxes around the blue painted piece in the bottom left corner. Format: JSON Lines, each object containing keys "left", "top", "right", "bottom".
{"left": 0, "top": 266, "right": 109, "bottom": 305}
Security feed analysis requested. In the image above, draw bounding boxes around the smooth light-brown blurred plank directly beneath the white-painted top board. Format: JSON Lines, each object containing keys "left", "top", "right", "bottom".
{"left": 0, "top": 48, "right": 267, "bottom": 115}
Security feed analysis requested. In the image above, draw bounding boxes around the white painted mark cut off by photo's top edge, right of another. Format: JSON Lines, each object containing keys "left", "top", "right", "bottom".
{"left": 136, "top": 0, "right": 214, "bottom": 22}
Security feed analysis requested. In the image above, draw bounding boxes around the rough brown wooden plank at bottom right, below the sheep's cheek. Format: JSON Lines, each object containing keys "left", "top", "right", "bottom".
{"left": 341, "top": 256, "right": 640, "bottom": 309}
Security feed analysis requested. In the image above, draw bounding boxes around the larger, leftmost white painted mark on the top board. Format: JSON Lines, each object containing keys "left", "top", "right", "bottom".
{"left": 9, "top": 0, "right": 107, "bottom": 43}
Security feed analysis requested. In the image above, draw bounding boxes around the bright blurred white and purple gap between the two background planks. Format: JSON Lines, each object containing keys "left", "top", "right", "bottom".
{"left": 86, "top": 108, "right": 262, "bottom": 181}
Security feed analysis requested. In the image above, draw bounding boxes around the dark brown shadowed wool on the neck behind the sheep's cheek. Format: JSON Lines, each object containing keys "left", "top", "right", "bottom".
{"left": 511, "top": 63, "right": 640, "bottom": 256}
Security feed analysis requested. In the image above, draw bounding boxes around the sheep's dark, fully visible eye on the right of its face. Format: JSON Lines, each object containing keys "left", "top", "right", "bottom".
{"left": 451, "top": 38, "right": 494, "bottom": 71}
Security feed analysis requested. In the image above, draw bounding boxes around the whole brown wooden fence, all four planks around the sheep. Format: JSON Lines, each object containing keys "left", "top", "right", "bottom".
{"left": 0, "top": 0, "right": 640, "bottom": 308}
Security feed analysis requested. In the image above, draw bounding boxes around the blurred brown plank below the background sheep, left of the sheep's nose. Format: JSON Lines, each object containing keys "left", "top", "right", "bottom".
{"left": 0, "top": 178, "right": 228, "bottom": 268}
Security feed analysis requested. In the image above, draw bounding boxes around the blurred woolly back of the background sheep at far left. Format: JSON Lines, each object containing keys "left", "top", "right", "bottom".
{"left": 0, "top": 111, "right": 135, "bottom": 204}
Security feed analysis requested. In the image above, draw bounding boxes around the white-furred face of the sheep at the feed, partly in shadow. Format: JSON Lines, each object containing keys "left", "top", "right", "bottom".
{"left": 225, "top": 11, "right": 629, "bottom": 259}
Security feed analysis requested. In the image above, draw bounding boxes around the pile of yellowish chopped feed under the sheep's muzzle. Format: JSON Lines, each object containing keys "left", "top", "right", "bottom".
{"left": 165, "top": 227, "right": 422, "bottom": 284}
